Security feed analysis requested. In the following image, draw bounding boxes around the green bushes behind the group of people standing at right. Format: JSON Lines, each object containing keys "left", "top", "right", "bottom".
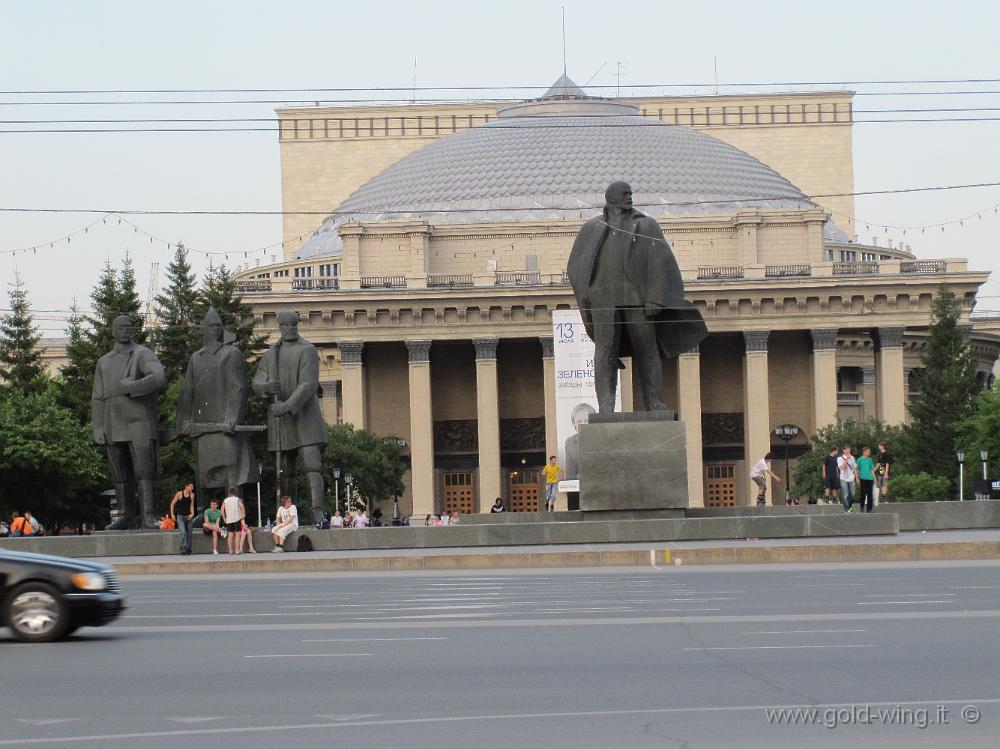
{"left": 792, "top": 419, "right": 906, "bottom": 498}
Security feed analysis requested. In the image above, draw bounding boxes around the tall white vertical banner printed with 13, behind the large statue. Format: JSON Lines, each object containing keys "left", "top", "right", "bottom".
{"left": 552, "top": 309, "right": 621, "bottom": 492}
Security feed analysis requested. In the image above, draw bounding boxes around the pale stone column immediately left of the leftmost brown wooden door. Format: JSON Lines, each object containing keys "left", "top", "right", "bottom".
{"left": 406, "top": 341, "right": 434, "bottom": 517}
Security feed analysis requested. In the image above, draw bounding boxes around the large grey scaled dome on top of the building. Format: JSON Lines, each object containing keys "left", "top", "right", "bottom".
{"left": 299, "top": 91, "right": 814, "bottom": 258}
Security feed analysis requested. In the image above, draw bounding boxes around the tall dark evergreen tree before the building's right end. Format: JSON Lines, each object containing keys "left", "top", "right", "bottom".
{"left": 907, "top": 286, "right": 979, "bottom": 486}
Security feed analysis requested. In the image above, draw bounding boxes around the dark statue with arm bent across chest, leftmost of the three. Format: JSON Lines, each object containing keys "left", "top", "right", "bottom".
{"left": 91, "top": 315, "right": 167, "bottom": 530}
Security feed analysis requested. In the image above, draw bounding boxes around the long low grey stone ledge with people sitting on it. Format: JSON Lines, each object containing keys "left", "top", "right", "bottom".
{"left": 0, "top": 512, "right": 898, "bottom": 557}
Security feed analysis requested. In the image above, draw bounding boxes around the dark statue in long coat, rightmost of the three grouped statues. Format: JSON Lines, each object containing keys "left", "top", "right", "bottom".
{"left": 252, "top": 312, "right": 328, "bottom": 523}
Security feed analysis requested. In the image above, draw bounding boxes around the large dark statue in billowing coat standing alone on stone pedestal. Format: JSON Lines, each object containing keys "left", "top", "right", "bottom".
{"left": 567, "top": 182, "right": 708, "bottom": 414}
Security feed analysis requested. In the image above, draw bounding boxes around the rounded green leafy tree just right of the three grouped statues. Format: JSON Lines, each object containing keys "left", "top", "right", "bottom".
{"left": 323, "top": 424, "right": 406, "bottom": 508}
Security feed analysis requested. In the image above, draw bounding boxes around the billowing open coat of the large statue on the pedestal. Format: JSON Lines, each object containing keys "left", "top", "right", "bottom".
{"left": 566, "top": 209, "right": 708, "bottom": 356}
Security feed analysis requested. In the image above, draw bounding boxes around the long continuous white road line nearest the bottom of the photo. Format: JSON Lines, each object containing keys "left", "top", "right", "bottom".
{"left": 0, "top": 697, "right": 1000, "bottom": 746}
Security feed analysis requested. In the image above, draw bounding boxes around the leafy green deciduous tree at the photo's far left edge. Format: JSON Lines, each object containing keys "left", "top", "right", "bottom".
{"left": 0, "top": 387, "right": 106, "bottom": 527}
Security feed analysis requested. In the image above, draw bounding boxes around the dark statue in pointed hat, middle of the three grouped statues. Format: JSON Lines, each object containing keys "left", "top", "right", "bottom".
{"left": 177, "top": 309, "right": 258, "bottom": 500}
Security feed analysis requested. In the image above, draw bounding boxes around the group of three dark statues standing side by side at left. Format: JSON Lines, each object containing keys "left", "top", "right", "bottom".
{"left": 91, "top": 309, "right": 327, "bottom": 530}
